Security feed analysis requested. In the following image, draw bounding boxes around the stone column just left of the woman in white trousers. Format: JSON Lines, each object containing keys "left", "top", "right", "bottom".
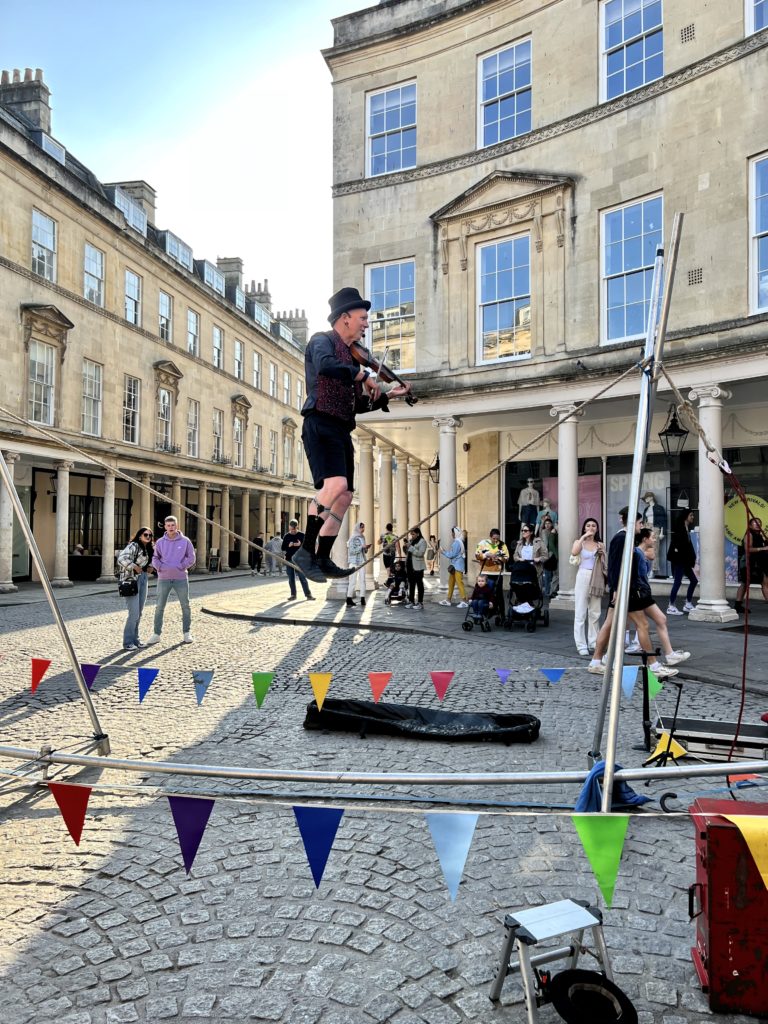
{"left": 549, "top": 404, "right": 582, "bottom": 608}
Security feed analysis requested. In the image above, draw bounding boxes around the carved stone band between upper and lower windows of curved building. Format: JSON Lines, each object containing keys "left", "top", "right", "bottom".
{"left": 332, "top": 29, "right": 768, "bottom": 199}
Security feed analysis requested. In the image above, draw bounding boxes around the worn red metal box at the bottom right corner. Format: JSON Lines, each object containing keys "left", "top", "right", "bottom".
{"left": 688, "top": 800, "right": 768, "bottom": 1017}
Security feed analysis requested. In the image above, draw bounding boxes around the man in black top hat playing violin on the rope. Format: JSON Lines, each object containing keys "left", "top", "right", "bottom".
{"left": 293, "top": 288, "right": 411, "bottom": 583}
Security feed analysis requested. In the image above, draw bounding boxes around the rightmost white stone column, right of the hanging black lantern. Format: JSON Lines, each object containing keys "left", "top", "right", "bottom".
{"left": 688, "top": 384, "right": 738, "bottom": 623}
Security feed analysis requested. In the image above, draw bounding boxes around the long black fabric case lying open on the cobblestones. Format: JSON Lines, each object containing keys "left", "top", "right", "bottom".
{"left": 304, "top": 699, "right": 542, "bottom": 744}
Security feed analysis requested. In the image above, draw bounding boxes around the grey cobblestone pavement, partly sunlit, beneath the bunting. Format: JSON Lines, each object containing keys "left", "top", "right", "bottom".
{"left": 0, "top": 578, "right": 765, "bottom": 1024}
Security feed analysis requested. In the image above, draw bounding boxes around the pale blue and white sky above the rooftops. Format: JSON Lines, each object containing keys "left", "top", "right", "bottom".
{"left": 0, "top": 0, "right": 375, "bottom": 330}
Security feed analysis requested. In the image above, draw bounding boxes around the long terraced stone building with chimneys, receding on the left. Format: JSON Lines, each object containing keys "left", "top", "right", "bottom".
{"left": 0, "top": 70, "right": 312, "bottom": 590}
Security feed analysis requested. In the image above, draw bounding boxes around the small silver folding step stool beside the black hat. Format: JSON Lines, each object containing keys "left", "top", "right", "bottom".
{"left": 490, "top": 899, "right": 613, "bottom": 1024}
